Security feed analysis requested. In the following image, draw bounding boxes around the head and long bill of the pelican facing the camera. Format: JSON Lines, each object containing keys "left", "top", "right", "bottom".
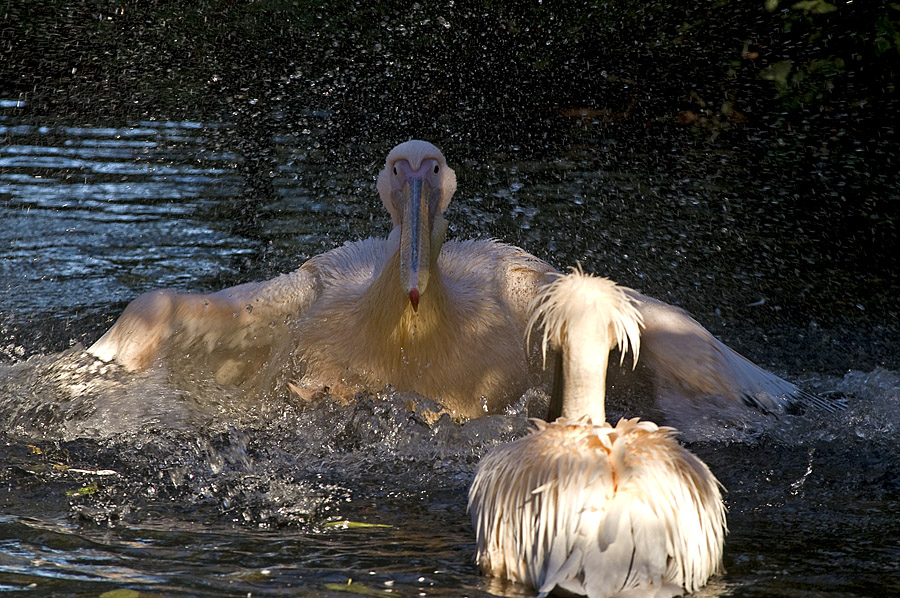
{"left": 377, "top": 140, "right": 456, "bottom": 310}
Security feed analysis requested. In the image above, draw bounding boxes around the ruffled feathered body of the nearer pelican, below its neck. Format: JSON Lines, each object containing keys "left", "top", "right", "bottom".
{"left": 469, "top": 419, "right": 727, "bottom": 597}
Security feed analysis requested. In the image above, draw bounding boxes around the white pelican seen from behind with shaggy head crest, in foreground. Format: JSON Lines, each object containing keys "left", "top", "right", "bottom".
{"left": 469, "top": 273, "right": 727, "bottom": 598}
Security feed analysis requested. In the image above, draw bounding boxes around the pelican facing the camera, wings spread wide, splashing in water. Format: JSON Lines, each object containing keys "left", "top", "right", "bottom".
{"left": 88, "top": 141, "right": 827, "bottom": 417}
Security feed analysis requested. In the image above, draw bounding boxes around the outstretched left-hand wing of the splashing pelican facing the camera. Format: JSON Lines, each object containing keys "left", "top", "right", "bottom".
{"left": 88, "top": 264, "right": 320, "bottom": 382}
